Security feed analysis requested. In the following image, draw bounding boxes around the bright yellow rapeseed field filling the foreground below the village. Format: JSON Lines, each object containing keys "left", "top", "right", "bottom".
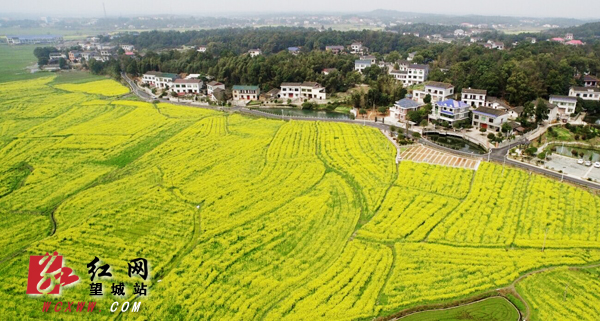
{"left": 0, "top": 78, "right": 600, "bottom": 320}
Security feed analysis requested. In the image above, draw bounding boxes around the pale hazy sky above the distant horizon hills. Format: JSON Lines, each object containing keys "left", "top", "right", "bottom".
{"left": 0, "top": 0, "right": 600, "bottom": 19}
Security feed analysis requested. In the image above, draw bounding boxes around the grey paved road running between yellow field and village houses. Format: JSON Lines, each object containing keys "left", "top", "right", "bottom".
{"left": 121, "top": 73, "right": 600, "bottom": 189}
